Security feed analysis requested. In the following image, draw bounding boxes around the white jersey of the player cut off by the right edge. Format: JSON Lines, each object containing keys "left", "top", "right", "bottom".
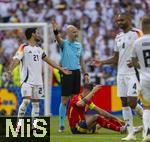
{"left": 132, "top": 35, "right": 150, "bottom": 81}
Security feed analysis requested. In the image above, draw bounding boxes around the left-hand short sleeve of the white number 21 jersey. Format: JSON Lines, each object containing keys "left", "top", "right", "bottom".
{"left": 13, "top": 44, "right": 26, "bottom": 60}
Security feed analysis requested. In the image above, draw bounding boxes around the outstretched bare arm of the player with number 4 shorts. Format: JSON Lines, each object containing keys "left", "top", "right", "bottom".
{"left": 91, "top": 52, "right": 119, "bottom": 66}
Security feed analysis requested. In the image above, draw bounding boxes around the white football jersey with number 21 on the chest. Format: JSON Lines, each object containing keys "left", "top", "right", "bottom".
{"left": 14, "top": 44, "right": 46, "bottom": 85}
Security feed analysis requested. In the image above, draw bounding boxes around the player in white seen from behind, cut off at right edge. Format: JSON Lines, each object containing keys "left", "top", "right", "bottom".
{"left": 132, "top": 15, "right": 150, "bottom": 142}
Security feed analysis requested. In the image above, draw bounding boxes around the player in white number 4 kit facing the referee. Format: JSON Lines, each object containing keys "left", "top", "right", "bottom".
{"left": 92, "top": 13, "right": 142, "bottom": 141}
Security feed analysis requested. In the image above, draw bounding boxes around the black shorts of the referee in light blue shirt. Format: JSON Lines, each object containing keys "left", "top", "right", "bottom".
{"left": 61, "top": 69, "right": 81, "bottom": 96}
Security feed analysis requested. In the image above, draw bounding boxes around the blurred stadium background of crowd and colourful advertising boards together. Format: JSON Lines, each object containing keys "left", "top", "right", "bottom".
{"left": 0, "top": 0, "right": 150, "bottom": 141}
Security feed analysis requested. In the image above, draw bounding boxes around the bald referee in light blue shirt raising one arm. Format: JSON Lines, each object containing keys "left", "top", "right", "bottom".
{"left": 52, "top": 22, "right": 89, "bottom": 132}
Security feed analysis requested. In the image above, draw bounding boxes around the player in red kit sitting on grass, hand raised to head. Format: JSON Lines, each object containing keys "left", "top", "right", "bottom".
{"left": 67, "top": 83, "right": 126, "bottom": 134}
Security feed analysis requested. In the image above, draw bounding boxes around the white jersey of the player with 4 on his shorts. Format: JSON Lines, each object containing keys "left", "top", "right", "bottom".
{"left": 114, "top": 28, "right": 142, "bottom": 74}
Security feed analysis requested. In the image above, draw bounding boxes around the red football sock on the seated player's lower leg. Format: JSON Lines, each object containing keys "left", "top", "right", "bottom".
{"left": 96, "top": 116, "right": 120, "bottom": 132}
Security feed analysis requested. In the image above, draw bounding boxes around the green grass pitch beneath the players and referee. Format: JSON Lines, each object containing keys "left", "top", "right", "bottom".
{"left": 50, "top": 116, "right": 142, "bottom": 142}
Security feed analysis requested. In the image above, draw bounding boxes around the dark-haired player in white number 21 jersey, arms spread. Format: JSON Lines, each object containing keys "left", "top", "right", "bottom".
{"left": 8, "top": 28, "right": 70, "bottom": 131}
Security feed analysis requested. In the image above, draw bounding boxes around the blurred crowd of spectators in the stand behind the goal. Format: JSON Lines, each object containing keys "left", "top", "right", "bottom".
{"left": 0, "top": 0, "right": 150, "bottom": 86}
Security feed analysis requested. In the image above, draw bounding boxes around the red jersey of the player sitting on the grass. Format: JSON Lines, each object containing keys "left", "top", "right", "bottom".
{"left": 67, "top": 95, "right": 89, "bottom": 128}
